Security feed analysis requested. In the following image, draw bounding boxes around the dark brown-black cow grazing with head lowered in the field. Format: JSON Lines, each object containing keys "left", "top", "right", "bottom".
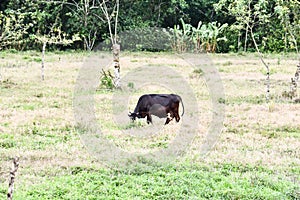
{"left": 128, "top": 94, "right": 184, "bottom": 124}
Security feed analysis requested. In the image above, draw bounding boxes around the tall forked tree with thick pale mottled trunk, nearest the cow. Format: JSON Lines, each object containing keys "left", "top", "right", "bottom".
{"left": 53, "top": 0, "right": 120, "bottom": 88}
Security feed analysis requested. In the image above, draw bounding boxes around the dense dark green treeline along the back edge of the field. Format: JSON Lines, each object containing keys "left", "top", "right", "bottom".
{"left": 0, "top": 0, "right": 300, "bottom": 52}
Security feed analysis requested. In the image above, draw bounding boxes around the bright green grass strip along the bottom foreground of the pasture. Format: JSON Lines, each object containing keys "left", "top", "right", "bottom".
{"left": 0, "top": 163, "right": 300, "bottom": 200}
